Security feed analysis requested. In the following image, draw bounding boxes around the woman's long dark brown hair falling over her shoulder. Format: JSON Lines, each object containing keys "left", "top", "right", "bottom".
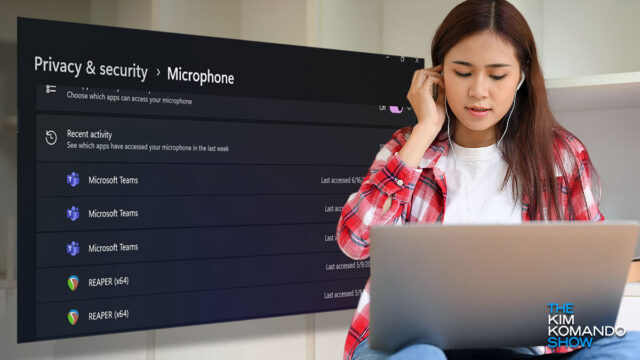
{"left": 431, "top": 0, "right": 600, "bottom": 220}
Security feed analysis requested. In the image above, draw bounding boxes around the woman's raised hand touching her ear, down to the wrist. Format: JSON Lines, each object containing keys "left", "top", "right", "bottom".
{"left": 407, "top": 65, "right": 445, "bottom": 131}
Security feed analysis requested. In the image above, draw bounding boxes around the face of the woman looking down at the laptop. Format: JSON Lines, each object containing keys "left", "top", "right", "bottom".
{"left": 444, "top": 31, "right": 520, "bottom": 137}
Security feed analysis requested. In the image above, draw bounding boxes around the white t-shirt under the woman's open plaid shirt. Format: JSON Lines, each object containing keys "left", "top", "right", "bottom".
{"left": 438, "top": 142, "right": 522, "bottom": 224}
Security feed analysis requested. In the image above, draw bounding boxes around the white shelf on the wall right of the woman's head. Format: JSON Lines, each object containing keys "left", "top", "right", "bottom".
{"left": 545, "top": 71, "right": 640, "bottom": 112}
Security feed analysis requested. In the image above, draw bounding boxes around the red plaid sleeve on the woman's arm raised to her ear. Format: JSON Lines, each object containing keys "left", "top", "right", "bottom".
{"left": 336, "top": 128, "right": 422, "bottom": 260}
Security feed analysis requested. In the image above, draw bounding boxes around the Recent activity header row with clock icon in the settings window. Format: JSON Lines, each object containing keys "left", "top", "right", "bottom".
{"left": 36, "top": 115, "right": 394, "bottom": 165}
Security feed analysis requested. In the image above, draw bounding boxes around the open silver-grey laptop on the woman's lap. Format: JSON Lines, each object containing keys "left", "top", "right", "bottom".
{"left": 369, "top": 221, "right": 640, "bottom": 351}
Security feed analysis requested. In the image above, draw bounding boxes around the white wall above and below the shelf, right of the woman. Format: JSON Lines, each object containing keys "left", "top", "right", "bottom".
{"left": 542, "top": 0, "right": 640, "bottom": 256}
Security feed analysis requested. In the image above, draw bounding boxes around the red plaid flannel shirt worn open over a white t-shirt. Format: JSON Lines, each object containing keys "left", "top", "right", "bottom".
{"left": 337, "top": 127, "right": 604, "bottom": 359}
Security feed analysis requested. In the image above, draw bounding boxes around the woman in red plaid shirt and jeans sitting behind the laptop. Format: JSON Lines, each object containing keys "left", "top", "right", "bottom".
{"left": 337, "top": 0, "right": 640, "bottom": 360}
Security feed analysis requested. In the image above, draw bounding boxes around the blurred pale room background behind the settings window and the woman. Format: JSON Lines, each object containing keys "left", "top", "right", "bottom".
{"left": 0, "top": 0, "right": 640, "bottom": 360}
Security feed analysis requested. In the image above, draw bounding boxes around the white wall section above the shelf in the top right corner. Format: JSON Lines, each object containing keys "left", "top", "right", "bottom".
{"left": 542, "top": 0, "right": 640, "bottom": 78}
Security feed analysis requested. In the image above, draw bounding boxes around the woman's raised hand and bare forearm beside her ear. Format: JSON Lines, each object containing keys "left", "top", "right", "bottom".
{"left": 398, "top": 65, "right": 445, "bottom": 168}
